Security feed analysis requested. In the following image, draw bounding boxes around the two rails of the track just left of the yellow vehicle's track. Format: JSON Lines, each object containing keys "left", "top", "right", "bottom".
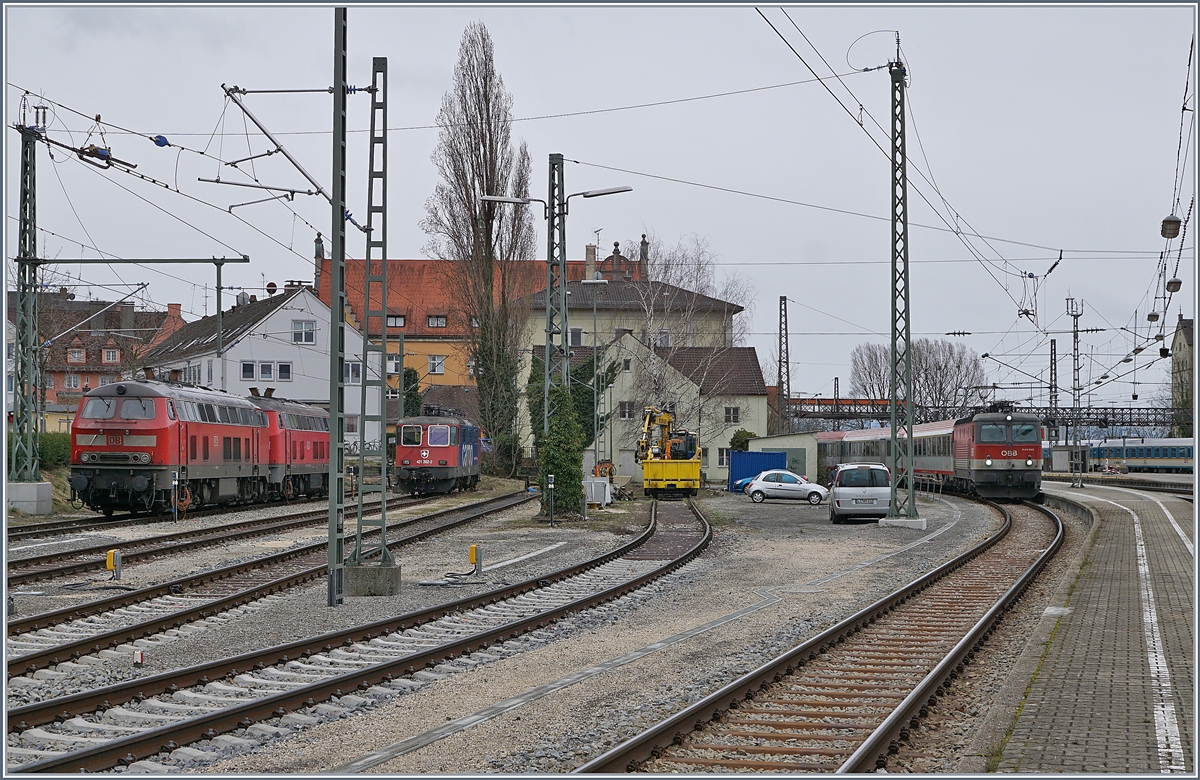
{"left": 7, "top": 491, "right": 532, "bottom": 677}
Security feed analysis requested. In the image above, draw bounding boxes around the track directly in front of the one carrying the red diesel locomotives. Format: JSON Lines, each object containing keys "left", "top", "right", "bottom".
{"left": 7, "top": 498, "right": 441, "bottom": 588}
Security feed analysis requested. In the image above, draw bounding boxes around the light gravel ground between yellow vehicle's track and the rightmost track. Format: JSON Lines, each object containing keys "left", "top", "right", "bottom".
{"left": 182, "top": 496, "right": 1000, "bottom": 774}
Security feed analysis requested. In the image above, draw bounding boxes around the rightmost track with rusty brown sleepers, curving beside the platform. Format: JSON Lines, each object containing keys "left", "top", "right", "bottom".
{"left": 576, "top": 504, "right": 1064, "bottom": 773}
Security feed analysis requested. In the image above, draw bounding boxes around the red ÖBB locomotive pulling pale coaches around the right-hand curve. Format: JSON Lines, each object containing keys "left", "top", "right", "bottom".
{"left": 817, "top": 412, "right": 1043, "bottom": 499}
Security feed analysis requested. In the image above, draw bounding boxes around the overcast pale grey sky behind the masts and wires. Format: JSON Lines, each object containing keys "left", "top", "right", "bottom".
{"left": 5, "top": 5, "right": 1196, "bottom": 404}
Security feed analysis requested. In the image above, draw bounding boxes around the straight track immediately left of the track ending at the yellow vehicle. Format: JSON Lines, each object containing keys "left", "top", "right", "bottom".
{"left": 7, "top": 491, "right": 534, "bottom": 685}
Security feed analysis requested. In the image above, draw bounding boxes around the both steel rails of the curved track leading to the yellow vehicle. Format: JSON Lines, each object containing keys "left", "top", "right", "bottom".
{"left": 8, "top": 502, "right": 713, "bottom": 772}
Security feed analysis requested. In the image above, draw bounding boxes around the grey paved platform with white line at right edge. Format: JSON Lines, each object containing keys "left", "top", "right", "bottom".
{"left": 996, "top": 484, "right": 1195, "bottom": 776}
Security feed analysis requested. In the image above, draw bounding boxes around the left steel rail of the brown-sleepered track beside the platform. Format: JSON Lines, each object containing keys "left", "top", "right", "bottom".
{"left": 575, "top": 502, "right": 1062, "bottom": 773}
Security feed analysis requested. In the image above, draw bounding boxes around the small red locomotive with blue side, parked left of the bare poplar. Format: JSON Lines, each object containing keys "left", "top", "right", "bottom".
{"left": 395, "top": 409, "right": 481, "bottom": 496}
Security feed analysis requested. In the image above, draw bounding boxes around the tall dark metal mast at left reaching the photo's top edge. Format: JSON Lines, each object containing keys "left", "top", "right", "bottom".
{"left": 328, "top": 7, "right": 346, "bottom": 607}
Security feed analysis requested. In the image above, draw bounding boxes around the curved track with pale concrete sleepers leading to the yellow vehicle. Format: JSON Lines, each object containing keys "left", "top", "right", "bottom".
{"left": 7, "top": 504, "right": 712, "bottom": 773}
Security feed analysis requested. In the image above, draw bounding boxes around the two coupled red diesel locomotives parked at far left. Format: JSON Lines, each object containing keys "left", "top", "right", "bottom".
{"left": 71, "top": 379, "right": 329, "bottom": 515}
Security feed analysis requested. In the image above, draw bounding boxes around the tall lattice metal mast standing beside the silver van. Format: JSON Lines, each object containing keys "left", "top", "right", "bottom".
{"left": 888, "top": 41, "right": 917, "bottom": 517}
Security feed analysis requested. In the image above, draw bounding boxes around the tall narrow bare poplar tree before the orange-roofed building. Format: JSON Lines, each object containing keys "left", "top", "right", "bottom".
{"left": 421, "top": 22, "right": 536, "bottom": 474}
